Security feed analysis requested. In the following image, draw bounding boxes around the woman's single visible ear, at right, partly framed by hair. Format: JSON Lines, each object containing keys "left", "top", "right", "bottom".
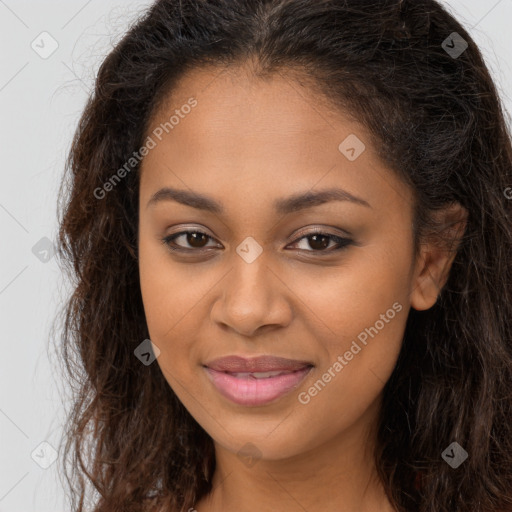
{"left": 411, "top": 203, "right": 468, "bottom": 311}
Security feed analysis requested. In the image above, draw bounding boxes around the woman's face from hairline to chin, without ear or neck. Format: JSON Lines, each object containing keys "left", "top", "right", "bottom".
{"left": 139, "top": 64, "right": 426, "bottom": 460}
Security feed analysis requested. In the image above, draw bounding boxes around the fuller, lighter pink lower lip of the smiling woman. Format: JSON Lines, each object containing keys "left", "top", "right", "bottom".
{"left": 205, "top": 366, "right": 313, "bottom": 406}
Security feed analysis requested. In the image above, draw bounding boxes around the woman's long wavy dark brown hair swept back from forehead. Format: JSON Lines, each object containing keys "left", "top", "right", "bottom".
{"left": 55, "top": 0, "right": 512, "bottom": 512}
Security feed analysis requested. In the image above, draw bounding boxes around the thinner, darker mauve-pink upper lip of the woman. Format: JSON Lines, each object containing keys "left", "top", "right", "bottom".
{"left": 205, "top": 356, "right": 313, "bottom": 373}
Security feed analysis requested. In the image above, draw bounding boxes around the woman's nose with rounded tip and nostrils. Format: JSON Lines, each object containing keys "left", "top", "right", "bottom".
{"left": 211, "top": 255, "right": 293, "bottom": 337}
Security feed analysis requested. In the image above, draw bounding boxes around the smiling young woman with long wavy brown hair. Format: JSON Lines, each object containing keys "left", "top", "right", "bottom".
{"left": 56, "top": 0, "right": 512, "bottom": 512}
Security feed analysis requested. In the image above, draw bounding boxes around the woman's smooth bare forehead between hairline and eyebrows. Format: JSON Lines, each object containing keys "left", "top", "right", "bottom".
{"left": 141, "top": 67, "right": 414, "bottom": 216}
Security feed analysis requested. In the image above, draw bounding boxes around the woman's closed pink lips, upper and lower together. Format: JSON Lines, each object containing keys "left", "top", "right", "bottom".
{"left": 205, "top": 356, "right": 313, "bottom": 406}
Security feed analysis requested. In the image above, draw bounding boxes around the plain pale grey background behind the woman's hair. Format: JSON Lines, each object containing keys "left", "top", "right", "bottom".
{"left": 0, "top": 0, "right": 512, "bottom": 512}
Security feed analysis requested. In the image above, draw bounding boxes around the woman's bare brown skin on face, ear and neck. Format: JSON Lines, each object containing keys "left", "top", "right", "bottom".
{"left": 139, "top": 64, "right": 463, "bottom": 512}
